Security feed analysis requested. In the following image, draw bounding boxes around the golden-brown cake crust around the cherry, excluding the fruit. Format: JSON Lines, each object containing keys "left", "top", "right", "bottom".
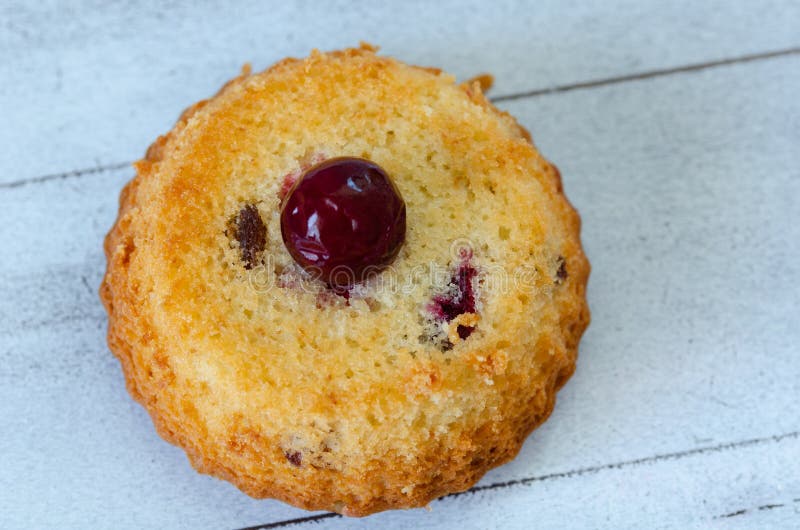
{"left": 100, "top": 46, "right": 589, "bottom": 516}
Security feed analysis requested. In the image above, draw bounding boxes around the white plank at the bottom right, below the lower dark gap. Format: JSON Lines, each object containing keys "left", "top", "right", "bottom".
{"left": 253, "top": 433, "right": 800, "bottom": 530}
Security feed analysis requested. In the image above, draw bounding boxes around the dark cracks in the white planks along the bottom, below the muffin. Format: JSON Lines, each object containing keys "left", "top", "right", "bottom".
{"left": 239, "top": 431, "right": 800, "bottom": 530}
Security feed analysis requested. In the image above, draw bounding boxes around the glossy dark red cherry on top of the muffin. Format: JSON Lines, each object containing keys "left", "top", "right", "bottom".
{"left": 281, "top": 157, "right": 406, "bottom": 290}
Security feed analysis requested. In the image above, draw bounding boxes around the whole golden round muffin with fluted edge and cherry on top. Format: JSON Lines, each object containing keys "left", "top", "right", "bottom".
{"left": 100, "top": 45, "right": 589, "bottom": 516}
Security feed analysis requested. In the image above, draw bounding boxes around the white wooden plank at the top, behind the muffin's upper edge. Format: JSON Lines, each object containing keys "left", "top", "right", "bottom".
{"left": 0, "top": 0, "right": 800, "bottom": 182}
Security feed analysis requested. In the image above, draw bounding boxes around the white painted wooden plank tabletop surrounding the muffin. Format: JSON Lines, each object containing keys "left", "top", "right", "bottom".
{"left": 0, "top": 0, "right": 800, "bottom": 530}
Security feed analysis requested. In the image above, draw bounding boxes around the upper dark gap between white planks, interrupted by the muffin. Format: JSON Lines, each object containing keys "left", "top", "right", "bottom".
{"left": 0, "top": 47, "right": 800, "bottom": 189}
